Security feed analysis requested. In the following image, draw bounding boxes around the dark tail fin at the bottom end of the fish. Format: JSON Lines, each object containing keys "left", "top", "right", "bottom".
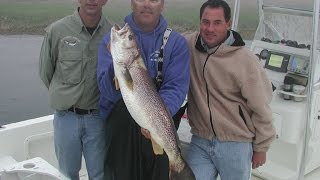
{"left": 169, "top": 159, "right": 196, "bottom": 180}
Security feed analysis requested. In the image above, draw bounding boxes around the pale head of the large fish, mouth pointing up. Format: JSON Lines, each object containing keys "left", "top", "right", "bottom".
{"left": 110, "top": 23, "right": 140, "bottom": 65}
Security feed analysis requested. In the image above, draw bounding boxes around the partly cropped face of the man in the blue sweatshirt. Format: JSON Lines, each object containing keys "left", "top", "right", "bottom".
{"left": 131, "top": 0, "right": 164, "bottom": 30}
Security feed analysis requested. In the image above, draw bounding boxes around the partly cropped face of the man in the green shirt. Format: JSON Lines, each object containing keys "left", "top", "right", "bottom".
{"left": 78, "top": 0, "right": 108, "bottom": 16}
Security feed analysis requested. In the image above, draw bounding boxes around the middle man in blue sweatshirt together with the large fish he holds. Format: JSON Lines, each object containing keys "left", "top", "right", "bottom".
{"left": 97, "top": 0, "right": 194, "bottom": 180}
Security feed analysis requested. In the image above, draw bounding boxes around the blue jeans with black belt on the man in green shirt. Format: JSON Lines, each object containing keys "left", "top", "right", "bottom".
{"left": 53, "top": 111, "right": 106, "bottom": 180}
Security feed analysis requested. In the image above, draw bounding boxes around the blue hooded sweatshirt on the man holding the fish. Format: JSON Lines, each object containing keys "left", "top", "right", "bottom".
{"left": 97, "top": 14, "right": 190, "bottom": 119}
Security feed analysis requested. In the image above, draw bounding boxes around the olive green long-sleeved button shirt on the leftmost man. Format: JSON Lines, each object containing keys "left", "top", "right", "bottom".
{"left": 39, "top": 11, "right": 111, "bottom": 110}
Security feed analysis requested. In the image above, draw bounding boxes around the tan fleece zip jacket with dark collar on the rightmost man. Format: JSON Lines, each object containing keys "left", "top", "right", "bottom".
{"left": 186, "top": 31, "right": 275, "bottom": 152}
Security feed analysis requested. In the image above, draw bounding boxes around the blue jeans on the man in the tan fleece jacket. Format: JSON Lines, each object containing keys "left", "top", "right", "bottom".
{"left": 186, "top": 135, "right": 252, "bottom": 180}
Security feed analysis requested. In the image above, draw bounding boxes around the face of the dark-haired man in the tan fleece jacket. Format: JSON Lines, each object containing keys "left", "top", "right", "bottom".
{"left": 200, "top": 7, "right": 231, "bottom": 48}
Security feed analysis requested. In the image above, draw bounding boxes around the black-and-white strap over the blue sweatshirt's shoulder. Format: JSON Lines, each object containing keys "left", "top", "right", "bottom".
{"left": 156, "top": 28, "right": 172, "bottom": 90}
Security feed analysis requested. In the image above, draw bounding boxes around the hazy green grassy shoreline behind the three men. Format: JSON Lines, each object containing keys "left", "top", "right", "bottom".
{"left": 0, "top": 0, "right": 258, "bottom": 38}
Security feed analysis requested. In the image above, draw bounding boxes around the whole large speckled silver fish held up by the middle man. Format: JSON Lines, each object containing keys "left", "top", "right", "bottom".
{"left": 110, "top": 24, "right": 195, "bottom": 180}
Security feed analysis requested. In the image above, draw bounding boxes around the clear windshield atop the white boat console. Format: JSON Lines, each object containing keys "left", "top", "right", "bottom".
{"left": 254, "top": 0, "right": 313, "bottom": 45}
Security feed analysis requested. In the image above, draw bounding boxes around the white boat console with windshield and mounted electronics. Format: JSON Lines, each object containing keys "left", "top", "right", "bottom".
{"left": 250, "top": 1, "right": 320, "bottom": 180}
